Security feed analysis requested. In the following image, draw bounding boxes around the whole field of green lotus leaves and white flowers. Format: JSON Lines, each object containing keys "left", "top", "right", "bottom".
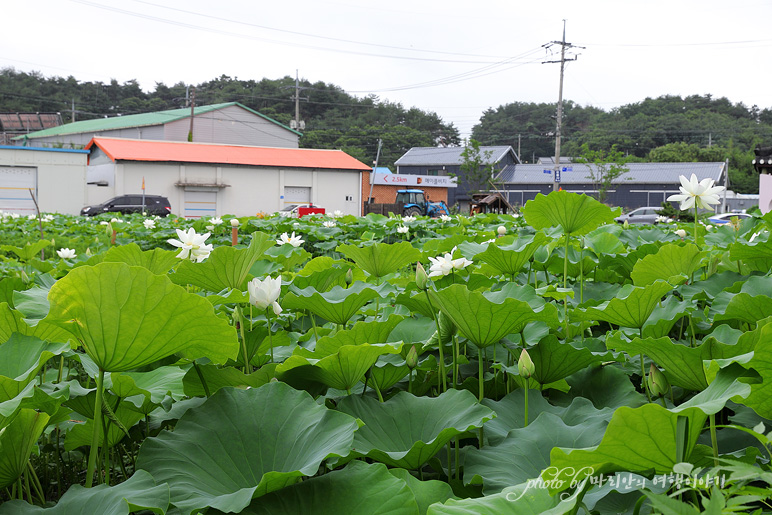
{"left": 0, "top": 190, "right": 772, "bottom": 515}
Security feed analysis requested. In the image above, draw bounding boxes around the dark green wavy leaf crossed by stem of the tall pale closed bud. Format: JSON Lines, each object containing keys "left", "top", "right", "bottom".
{"left": 483, "top": 396, "right": 614, "bottom": 446}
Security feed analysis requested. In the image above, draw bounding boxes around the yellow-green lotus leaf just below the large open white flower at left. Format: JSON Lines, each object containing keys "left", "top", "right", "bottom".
{"left": 171, "top": 232, "right": 275, "bottom": 292}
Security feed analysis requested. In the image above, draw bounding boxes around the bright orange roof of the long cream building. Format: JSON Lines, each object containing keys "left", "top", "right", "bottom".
{"left": 86, "top": 138, "right": 370, "bottom": 171}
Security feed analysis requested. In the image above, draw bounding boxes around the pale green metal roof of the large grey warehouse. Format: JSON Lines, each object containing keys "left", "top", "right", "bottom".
{"left": 13, "top": 102, "right": 302, "bottom": 140}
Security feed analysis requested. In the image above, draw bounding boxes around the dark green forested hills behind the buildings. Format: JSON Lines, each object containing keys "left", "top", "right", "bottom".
{"left": 0, "top": 69, "right": 772, "bottom": 193}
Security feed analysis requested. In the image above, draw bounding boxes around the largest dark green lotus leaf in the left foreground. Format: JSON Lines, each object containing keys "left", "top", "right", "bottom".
{"left": 137, "top": 382, "right": 357, "bottom": 514}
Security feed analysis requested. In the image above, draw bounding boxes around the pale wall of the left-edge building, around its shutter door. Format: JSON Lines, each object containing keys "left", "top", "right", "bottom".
{"left": 0, "top": 147, "right": 88, "bottom": 215}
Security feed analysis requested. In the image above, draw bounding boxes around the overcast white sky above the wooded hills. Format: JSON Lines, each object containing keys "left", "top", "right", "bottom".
{"left": 0, "top": 0, "right": 772, "bottom": 137}
